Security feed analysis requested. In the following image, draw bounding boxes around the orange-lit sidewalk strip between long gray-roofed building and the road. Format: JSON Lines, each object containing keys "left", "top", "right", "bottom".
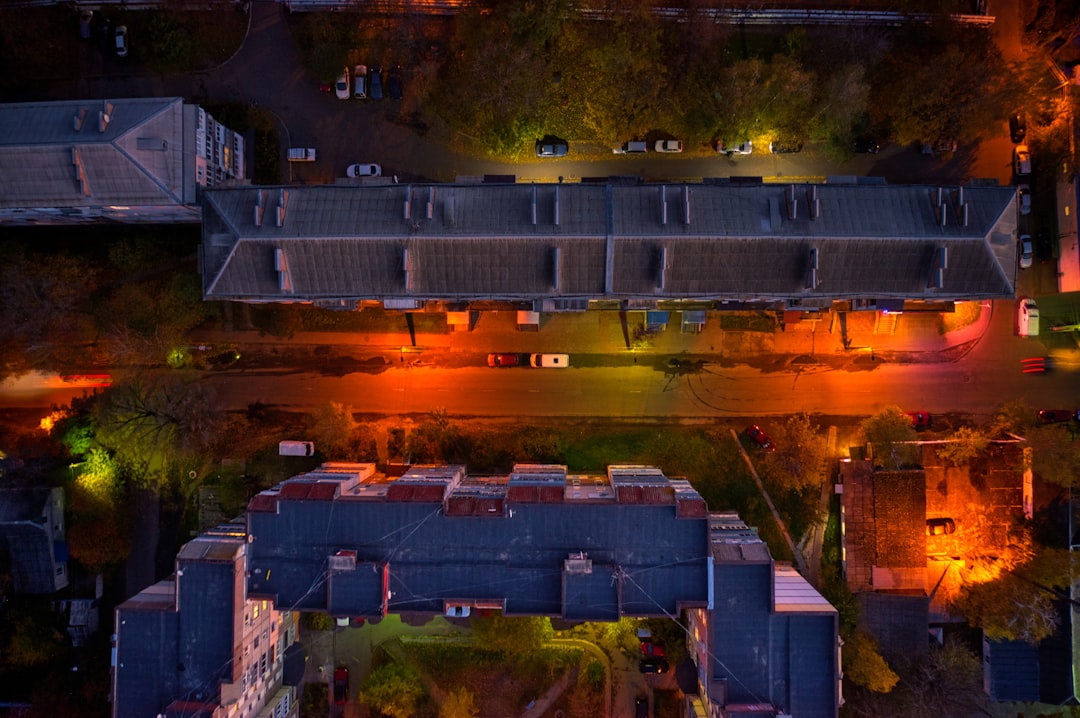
{"left": 192, "top": 301, "right": 994, "bottom": 368}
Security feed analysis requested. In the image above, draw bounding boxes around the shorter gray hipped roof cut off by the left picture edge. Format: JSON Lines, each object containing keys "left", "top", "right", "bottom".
{"left": 0, "top": 97, "right": 195, "bottom": 208}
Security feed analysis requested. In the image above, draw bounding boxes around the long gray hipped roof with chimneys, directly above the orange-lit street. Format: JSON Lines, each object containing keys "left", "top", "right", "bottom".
{"left": 203, "top": 184, "right": 1016, "bottom": 300}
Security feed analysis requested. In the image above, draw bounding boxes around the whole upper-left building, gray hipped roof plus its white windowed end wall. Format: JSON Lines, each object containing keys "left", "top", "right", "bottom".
{"left": 0, "top": 97, "right": 246, "bottom": 226}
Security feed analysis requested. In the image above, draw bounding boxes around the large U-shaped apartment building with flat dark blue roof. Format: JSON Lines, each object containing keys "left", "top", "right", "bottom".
{"left": 113, "top": 462, "right": 839, "bottom": 718}
